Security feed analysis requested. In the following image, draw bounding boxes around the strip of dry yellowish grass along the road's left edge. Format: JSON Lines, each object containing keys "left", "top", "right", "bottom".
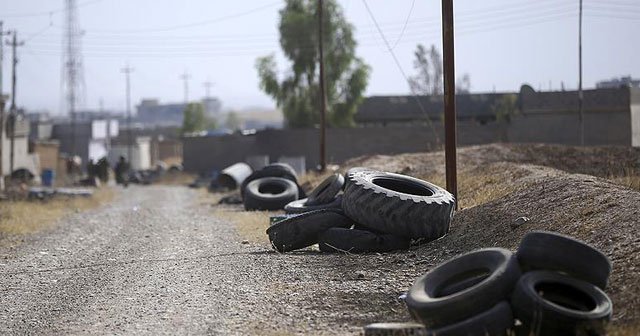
{"left": 0, "top": 188, "right": 114, "bottom": 237}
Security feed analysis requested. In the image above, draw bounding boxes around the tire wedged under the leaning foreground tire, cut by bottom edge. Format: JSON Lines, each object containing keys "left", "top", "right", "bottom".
{"left": 427, "top": 301, "right": 514, "bottom": 336}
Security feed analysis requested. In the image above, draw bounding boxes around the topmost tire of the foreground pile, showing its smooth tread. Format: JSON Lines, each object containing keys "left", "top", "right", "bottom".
{"left": 516, "top": 231, "right": 611, "bottom": 289}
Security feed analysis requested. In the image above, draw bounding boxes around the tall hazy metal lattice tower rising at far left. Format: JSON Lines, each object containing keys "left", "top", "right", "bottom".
{"left": 62, "top": 0, "right": 84, "bottom": 155}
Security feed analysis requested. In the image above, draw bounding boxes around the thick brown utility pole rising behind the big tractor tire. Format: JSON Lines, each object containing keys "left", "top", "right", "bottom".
{"left": 442, "top": 0, "right": 458, "bottom": 204}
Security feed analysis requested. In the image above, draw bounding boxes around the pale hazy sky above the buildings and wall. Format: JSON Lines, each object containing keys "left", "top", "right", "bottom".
{"left": 0, "top": 0, "right": 640, "bottom": 113}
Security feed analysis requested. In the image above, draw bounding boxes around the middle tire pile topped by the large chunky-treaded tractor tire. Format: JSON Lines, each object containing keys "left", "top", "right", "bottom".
{"left": 267, "top": 167, "right": 455, "bottom": 253}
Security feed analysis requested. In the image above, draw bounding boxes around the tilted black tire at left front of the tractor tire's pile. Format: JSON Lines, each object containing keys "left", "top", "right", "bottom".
{"left": 267, "top": 210, "right": 353, "bottom": 252}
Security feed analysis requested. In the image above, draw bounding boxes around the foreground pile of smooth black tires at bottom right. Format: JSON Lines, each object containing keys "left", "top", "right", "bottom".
{"left": 405, "top": 231, "right": 612, "bottom": 336}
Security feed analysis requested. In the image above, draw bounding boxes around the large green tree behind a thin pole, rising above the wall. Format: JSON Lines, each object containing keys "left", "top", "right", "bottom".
{"left": 256, "top": 0, "right": 370, "bottom": 127}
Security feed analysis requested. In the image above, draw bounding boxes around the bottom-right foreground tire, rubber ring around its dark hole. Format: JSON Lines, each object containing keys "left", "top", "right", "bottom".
{"left": 511, "top": 271, "right": 613, "bottom": 335}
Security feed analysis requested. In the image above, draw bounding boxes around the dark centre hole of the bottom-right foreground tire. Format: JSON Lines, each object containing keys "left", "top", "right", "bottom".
{"left": 534, "top": 282, "right": 596, "bottom": 312}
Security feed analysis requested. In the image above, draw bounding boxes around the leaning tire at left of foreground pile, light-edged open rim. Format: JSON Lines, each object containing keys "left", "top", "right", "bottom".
{"left": 405, "top": 248, "right": 520, "bottom": 329}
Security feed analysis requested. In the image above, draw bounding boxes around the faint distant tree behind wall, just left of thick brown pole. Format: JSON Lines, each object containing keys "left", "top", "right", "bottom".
{"left": 409, "top": 44, "right": 442, "bottom": 96}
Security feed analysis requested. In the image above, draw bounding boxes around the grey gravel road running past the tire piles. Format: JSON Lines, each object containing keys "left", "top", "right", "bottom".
{"left": 0, "top": 186, "right": 413, "bottom": 335}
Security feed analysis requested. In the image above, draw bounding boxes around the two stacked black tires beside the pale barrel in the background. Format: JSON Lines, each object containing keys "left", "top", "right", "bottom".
{"left": 240, "top": 163, "right": 304, "bottom": 210}
